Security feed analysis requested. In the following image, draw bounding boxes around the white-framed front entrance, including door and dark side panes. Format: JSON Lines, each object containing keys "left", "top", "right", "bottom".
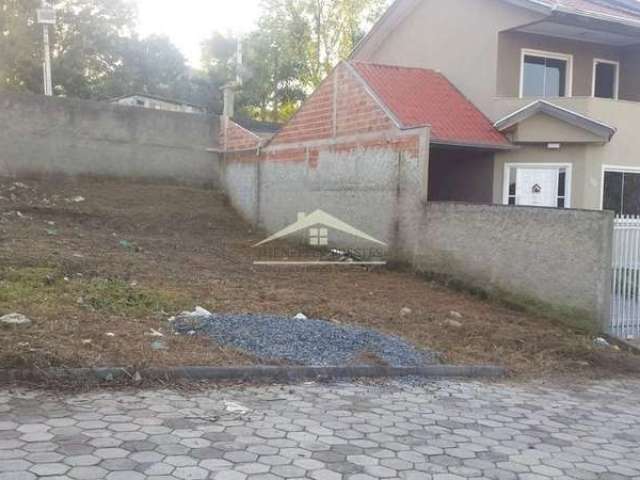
{"left": 504, "top": 164, "right": 571, "bottom": 208}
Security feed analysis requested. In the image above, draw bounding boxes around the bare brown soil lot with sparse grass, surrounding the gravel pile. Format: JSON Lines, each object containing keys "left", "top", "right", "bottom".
{"left": 0, "top": 178, "right": 640, "bottom": 377}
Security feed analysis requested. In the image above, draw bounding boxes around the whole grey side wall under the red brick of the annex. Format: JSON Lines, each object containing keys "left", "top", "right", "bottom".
{"left": 223, "top": 143, "right": 428, "bottom": 249}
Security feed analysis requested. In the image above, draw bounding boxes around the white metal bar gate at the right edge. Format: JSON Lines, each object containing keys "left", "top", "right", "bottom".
{"left": 609, "top": 216, "right": 640, "bottom": 338}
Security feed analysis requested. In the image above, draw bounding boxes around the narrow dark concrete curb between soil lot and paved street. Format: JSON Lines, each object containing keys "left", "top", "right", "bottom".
{"left": 0, "top": 365, "right": 506, "bottom": 383}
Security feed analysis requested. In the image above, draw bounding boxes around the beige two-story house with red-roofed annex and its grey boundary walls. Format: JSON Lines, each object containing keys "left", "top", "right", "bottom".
{"left": 216, "top": 0, "right": 640, "bottom": 334}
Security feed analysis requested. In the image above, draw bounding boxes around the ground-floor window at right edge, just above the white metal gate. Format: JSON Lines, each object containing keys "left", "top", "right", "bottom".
{"left": 602, "top": 170, "right": 640, "bottom": 215}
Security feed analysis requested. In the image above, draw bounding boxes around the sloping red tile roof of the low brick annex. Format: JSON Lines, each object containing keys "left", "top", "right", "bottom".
{"left": 351, "top": 62, "right": 510, "bottom": 147}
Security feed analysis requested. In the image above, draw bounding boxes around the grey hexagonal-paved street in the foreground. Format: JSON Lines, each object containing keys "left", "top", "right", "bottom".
{"left": 0, "top": 379, "right": 640, "bottom": 480}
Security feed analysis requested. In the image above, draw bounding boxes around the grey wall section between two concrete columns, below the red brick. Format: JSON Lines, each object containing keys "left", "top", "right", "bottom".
{"left": 260, "top": 148, "right": 404, "bottom": 248}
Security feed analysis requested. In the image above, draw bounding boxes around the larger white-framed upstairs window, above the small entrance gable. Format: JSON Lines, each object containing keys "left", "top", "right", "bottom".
{"left": 520, "top": 50, "right": 573, "bottom": 97}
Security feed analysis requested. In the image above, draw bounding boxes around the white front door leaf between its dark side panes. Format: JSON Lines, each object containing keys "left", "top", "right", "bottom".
{"left": 516, "top": 168, "right": 558, "bottom": 208}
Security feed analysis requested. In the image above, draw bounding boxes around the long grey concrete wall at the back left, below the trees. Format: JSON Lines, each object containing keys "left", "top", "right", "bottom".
{"left": 0, "top": 93, "right": 219, "bottom": 184}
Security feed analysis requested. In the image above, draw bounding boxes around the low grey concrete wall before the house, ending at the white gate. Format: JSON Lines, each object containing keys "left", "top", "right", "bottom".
{"left": 402, "top": 203, "right": 613, "bottom": 325}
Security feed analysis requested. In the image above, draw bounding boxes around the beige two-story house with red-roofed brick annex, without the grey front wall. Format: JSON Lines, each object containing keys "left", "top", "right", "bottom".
{"left": 224, "top": 0, "right": 640, "bottom": 216}
